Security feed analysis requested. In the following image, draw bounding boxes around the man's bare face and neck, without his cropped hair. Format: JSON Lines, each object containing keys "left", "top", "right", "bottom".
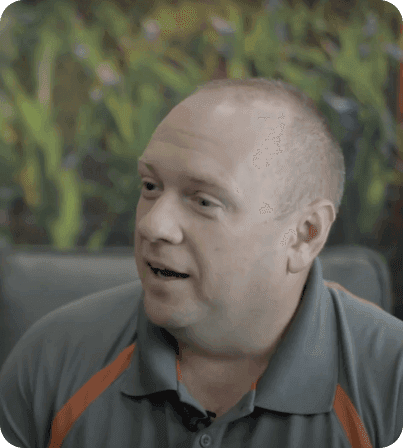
{"left": 135, "top": 79, "right": 339, "bottom": 415}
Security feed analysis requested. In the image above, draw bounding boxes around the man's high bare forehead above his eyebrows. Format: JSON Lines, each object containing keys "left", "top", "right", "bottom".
{"left": 146, "top": 91, "right": 291, "bottom": 189}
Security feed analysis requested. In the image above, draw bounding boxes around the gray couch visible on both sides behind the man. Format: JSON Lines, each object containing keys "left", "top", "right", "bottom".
{"left": 0, "top": 242, "right": 394, "bottom": 368}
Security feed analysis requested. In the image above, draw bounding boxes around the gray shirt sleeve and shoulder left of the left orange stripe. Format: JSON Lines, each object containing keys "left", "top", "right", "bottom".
{"left": 0, "top": 280, "right": 143, "bottom": 446}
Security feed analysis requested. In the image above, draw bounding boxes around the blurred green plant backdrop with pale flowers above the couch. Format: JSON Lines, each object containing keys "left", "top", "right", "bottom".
{"left": 0, "top": 0, "right": 403, "bottom": 319}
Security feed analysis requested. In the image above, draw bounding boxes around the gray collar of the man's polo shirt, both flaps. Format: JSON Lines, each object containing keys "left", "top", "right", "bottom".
{"left": 121, "top": 258, "right": 338, "bottom": 414}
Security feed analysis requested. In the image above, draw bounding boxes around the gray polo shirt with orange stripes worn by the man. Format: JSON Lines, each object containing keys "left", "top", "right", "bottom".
{"left": 0, "top": 258, "right": 403, "bottom": 448}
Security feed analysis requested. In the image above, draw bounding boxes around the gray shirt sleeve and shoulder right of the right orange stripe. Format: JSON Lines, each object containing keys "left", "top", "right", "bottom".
{"left": 325, "top": 282, "right": 403, "bottom": 446}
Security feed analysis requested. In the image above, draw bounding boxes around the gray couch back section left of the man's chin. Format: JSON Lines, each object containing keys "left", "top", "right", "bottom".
{"left": 0, "top": 245, "right": 138, "bottom": 372}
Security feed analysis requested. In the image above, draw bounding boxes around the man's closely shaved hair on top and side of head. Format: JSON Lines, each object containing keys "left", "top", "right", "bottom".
{"left": 184, "top": 78, "right": 345, "bottom": 221}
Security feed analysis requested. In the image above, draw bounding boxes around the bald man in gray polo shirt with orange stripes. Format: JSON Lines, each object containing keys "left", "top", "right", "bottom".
{"left": 0, "top": 79, "right": 403, "bottom": 448}
